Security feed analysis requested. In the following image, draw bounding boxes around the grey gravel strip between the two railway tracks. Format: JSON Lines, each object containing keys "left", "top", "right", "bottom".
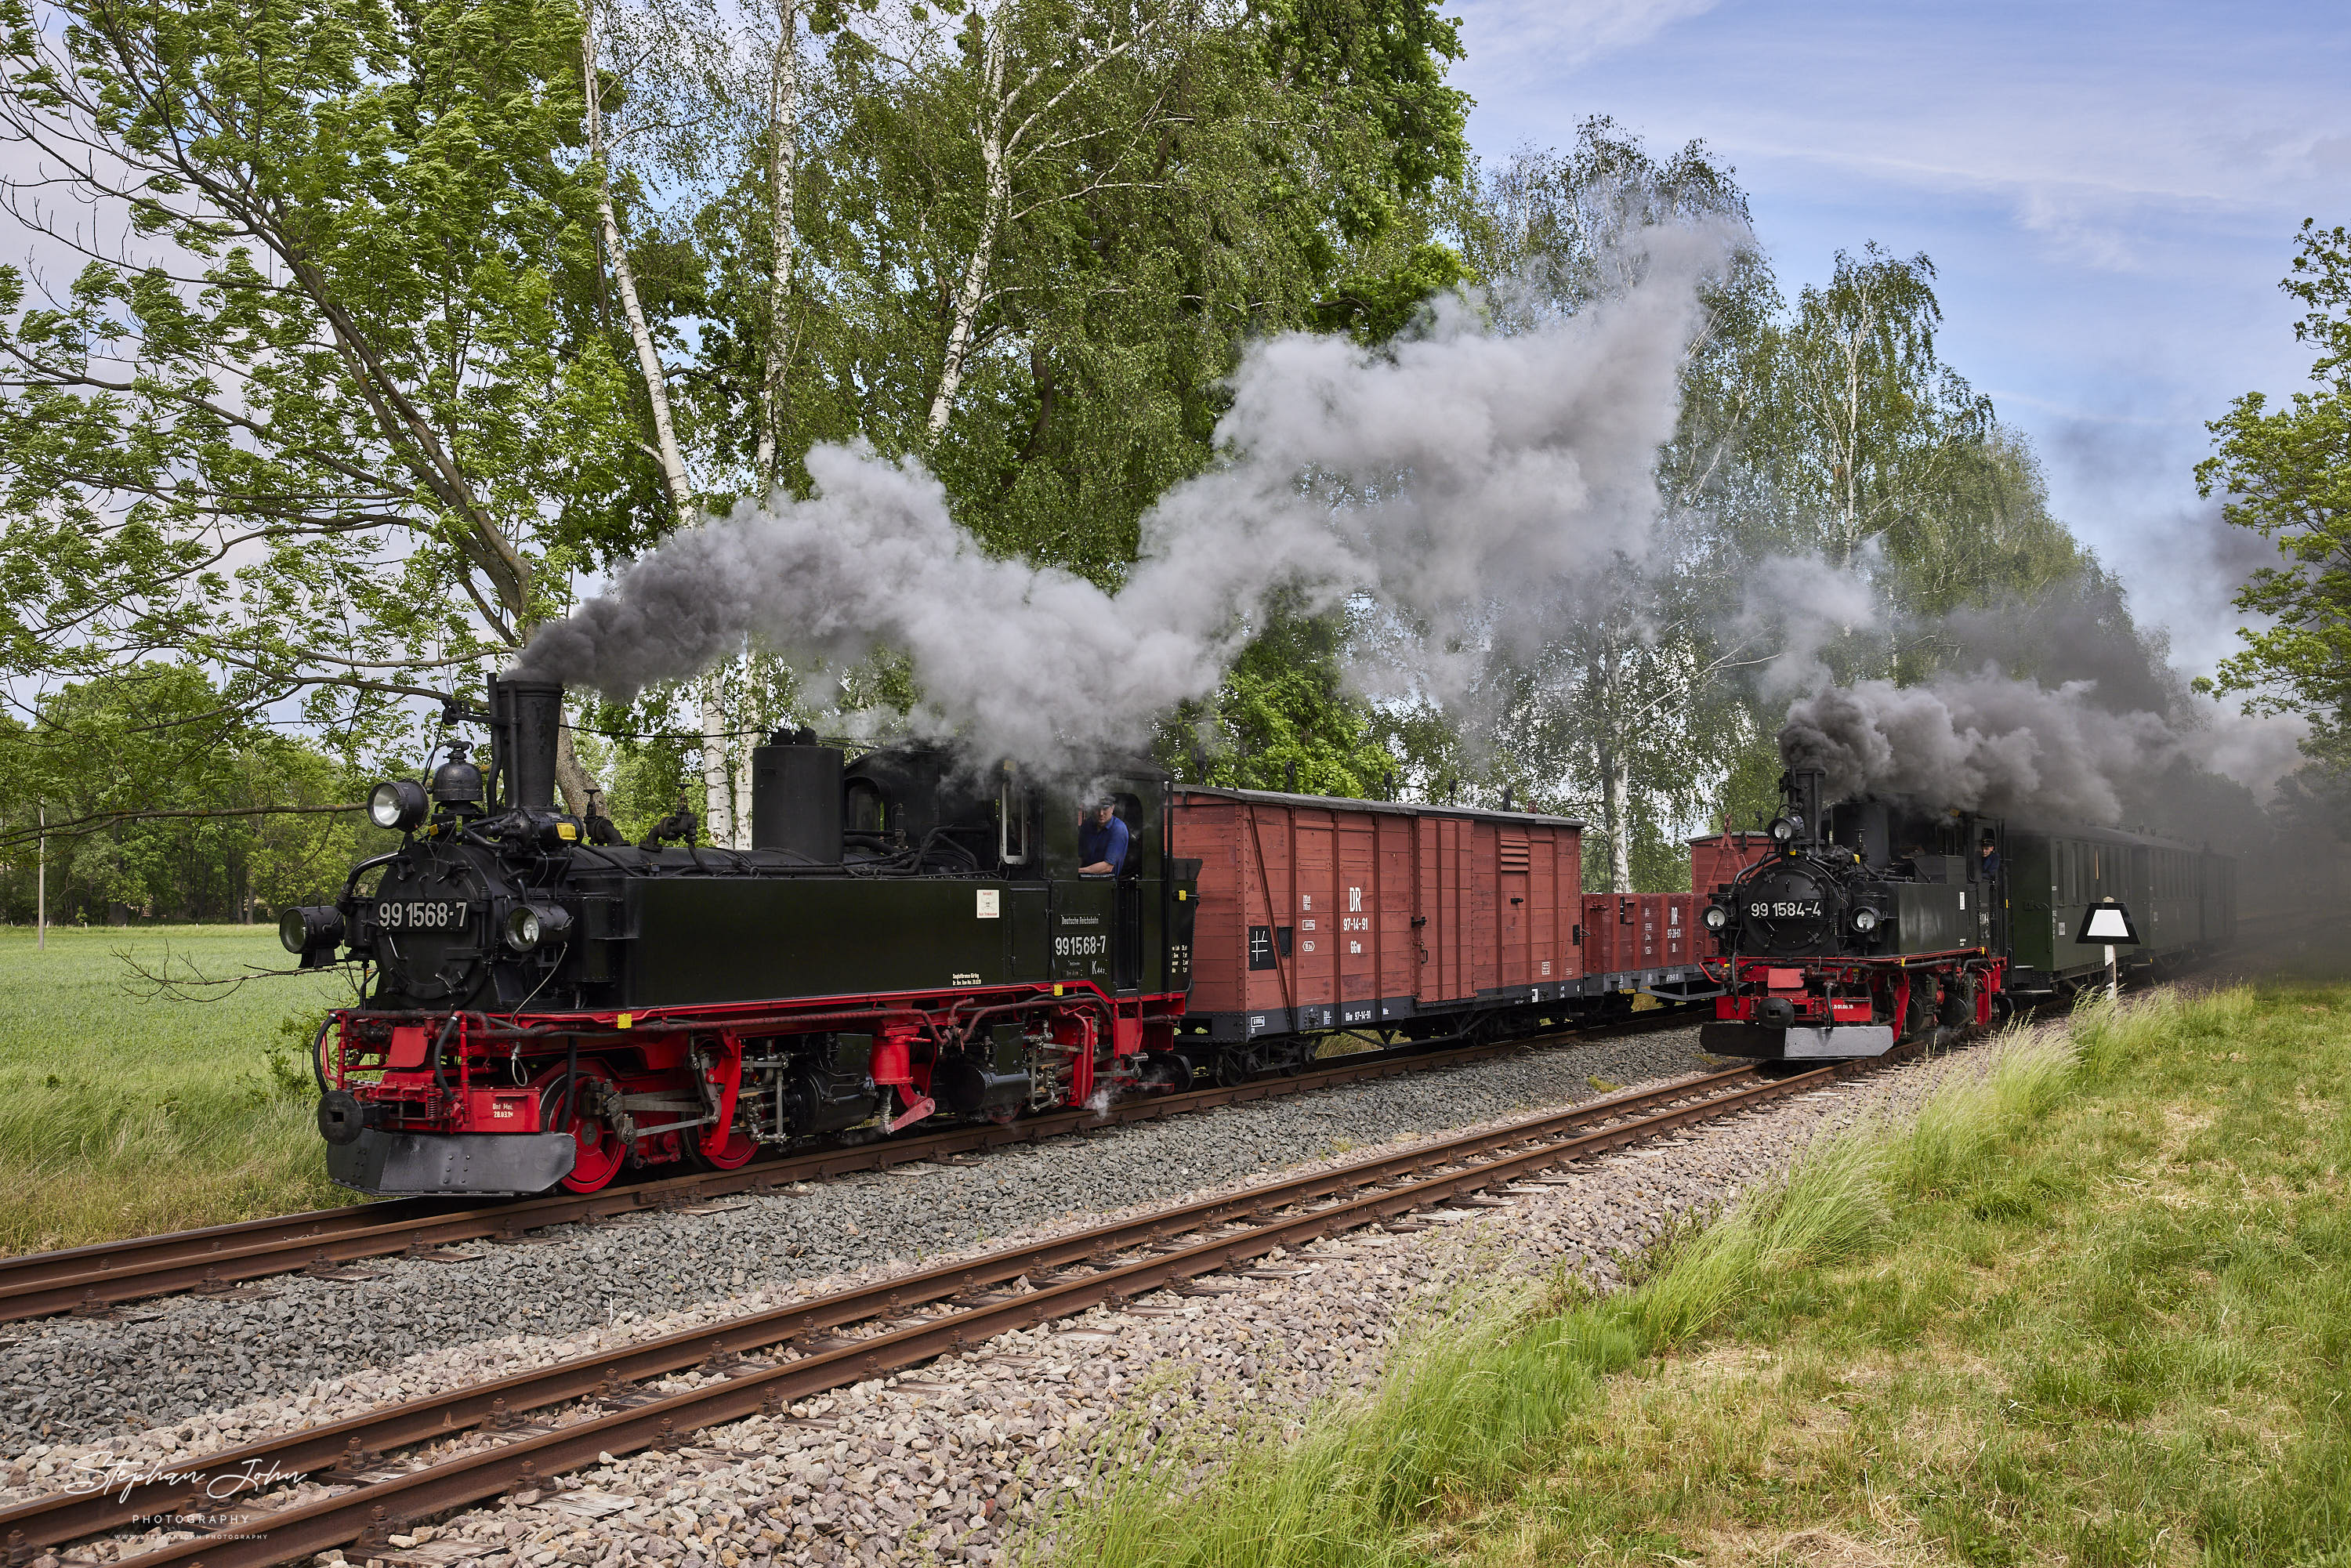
{"left": 0, "top": 1027, "right": 1709, "bottom": 1479}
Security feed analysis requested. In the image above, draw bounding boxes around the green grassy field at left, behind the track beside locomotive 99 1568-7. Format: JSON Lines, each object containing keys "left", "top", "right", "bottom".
{"left": 0, "top": 926, "right": 350, "bottom": 1253}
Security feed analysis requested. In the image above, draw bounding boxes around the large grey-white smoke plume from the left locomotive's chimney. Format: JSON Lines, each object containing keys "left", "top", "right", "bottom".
{"left": 517, "top": 228, "right": 1733, "bottom": 771}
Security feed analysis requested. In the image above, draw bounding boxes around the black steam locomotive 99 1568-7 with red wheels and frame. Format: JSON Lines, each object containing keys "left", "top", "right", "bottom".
{"left": 280, "top": 679, "right": 1199, "bottom": 1192}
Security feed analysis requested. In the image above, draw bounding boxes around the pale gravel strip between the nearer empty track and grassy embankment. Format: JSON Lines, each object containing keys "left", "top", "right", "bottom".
{"left": 45, "top": 1034, "right": 1984, "bottom": 1568}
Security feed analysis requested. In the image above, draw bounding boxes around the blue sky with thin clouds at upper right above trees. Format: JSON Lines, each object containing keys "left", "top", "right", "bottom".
{"left": 1451, "top": 0, "right": 2351, "bottom": 670}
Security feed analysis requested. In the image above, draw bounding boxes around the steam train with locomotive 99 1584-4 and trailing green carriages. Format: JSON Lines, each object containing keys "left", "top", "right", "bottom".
{"left": 1700, "top": 769, "right": 2236, "bottom": 1060}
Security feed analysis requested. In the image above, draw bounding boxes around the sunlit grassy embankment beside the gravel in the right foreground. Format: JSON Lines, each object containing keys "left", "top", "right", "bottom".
{"left": 1060, "top": 987, "right": 2351, "bottom": 1568}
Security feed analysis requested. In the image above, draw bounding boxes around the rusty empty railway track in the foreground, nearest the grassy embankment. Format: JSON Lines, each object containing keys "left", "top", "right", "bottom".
{"left": 0, "top": 1046, "right": 1916, "bottom": 1568}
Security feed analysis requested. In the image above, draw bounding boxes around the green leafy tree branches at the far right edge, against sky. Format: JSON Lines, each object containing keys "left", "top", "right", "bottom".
{"left": 2196, "top": 221, "right": 2351, "bottom": 771}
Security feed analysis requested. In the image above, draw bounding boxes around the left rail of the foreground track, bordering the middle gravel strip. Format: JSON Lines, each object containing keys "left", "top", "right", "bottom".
{"left": 0, "top": 1067, "right": 1768, "bottom": 1549}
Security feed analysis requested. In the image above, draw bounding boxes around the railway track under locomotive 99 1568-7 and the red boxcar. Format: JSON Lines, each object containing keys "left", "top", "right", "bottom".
{"left": 0, "top": 1009, "right": 1695, "bottom": 1324}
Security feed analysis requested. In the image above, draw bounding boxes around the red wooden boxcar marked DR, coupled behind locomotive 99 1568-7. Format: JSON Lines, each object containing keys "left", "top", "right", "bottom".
{"left": 1168, "top": 785, "right": 1596, "bottom": 1039}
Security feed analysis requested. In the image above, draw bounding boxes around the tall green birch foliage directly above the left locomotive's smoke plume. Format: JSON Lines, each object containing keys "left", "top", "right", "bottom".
{"left": 656, "top": 0, "right": 1467, "bottom": 583}
